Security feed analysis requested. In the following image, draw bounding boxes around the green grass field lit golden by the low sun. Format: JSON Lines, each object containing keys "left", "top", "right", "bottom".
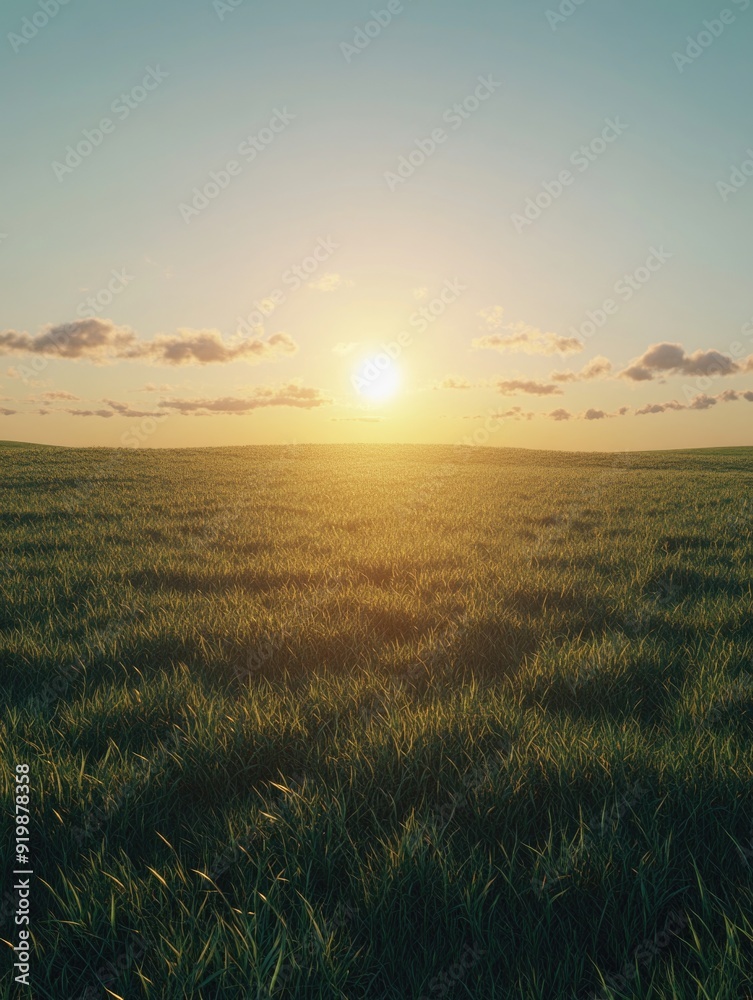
{"left": 0, "top": 446, "right": 753, "bottom": 1000}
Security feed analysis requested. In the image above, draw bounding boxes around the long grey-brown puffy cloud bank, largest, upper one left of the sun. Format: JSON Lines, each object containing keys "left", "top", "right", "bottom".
{"left": 0, "top": 319, "right": 298, "bottom": 366}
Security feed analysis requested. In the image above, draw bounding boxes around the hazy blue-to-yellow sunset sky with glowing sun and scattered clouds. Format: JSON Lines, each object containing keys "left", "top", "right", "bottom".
{"left": 0, "top": 0, "right": 753, "bottom": 451}
